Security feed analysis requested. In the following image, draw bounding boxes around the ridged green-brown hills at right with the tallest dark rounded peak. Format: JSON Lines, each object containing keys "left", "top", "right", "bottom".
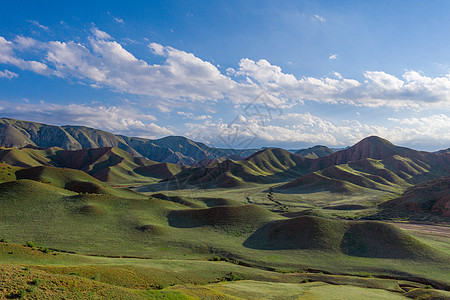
{"left": 163, "top": 137, "right": 450, "bottom": 192}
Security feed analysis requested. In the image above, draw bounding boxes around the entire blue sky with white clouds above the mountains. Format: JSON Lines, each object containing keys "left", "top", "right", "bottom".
{"left": 0, "top": 0, "right": 450, "bottom": 151}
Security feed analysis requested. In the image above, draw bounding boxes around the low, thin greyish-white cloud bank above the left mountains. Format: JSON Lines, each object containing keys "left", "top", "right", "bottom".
{"left": 0, "top": 102, "right": 173, "bottom": 138}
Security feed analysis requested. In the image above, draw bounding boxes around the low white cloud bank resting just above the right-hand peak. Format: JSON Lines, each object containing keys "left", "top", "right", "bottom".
{"left": 184, "top": 113, "right": 450, "bottom": 150}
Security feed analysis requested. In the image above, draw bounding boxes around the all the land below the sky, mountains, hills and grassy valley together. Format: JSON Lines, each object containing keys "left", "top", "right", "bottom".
{"left": 0, "top": 119, "right": 450, "bottom": 299}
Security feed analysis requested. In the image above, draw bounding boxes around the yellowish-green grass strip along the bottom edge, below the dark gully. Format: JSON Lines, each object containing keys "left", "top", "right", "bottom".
{"left": 0, "top": 242, "right": 448, "bottom": 299}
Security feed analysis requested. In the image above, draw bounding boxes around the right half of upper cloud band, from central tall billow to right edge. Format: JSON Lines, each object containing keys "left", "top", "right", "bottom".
{"left": 235, "top": 59, "right": 450, "bottom": 107}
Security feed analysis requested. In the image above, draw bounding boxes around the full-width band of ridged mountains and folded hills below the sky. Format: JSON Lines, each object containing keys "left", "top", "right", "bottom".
{"left": 0, "top": 119, "right": 450, "bottom": 214}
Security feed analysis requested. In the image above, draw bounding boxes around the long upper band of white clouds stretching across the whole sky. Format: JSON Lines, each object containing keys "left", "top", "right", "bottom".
{"left": 0, "top": 27, "right": 450, "bottom": 107}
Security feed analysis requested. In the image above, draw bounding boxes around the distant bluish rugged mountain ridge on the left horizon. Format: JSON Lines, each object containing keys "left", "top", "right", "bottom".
{"left": 0, "top": 118, "right": 253, "bottom": 165}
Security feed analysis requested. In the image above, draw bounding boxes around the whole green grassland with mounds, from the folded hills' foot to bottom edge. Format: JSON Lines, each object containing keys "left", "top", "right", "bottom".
{"left": 0, "top": 162, "right": 450, "bottom": 299}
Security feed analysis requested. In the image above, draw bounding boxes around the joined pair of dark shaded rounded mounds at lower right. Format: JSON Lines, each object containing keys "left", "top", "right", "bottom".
{"left": 244, "top": 216, "right": 436, "bottom": 259}
